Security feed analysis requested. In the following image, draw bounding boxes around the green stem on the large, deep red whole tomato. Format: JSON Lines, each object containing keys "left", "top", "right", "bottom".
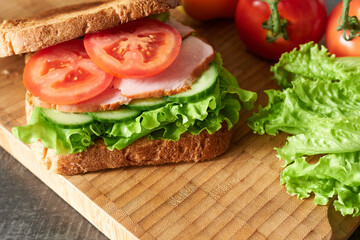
{"left": 261, "top": 0, "right": 288, "bottom": 43}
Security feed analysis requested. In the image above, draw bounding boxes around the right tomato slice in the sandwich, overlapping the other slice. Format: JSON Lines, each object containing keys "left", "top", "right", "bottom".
{"left": 84, "top": 19, "right": 182, "bottom": 78}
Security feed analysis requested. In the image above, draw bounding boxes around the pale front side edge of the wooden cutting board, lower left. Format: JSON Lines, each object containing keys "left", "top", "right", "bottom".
{"left": 0, "top": 125, "right": 138, "bottom": 240}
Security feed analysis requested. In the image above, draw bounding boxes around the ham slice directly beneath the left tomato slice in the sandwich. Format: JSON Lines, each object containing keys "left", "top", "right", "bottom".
{"left": 26, "top": 87, "right": 131, "bottom": 112}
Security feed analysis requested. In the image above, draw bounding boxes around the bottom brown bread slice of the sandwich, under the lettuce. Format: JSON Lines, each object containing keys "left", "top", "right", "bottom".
{"left": 26, "top": 94, "right": 233, "bottom": 175}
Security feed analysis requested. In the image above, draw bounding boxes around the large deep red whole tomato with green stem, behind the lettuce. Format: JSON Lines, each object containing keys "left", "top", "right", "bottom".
{"left": 235, "top": 0, "right": 326, "bottom": 60}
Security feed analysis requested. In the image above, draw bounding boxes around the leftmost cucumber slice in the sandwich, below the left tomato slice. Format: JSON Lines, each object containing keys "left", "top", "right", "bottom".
{"left": 40, "top": 108, "right": 94, "bottom": 128}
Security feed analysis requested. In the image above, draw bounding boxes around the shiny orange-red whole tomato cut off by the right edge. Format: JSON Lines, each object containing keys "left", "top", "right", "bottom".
{"left": 325, "top": 0, "right": 360, "bottom": 57}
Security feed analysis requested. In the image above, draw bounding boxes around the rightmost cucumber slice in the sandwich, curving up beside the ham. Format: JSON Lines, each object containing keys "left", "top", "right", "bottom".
{"left": 167, "top": 64, "right": 219, "bottom": 102}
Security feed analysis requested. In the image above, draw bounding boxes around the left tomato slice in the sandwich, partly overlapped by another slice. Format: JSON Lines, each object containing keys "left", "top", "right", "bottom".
{"left": 23, "top": 39, "right": 113, "bottom": 104}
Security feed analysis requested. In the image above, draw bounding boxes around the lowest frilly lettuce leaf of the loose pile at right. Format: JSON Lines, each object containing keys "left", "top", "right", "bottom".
{"left": 281, "top": 151, "right": 360, "bottom": 216}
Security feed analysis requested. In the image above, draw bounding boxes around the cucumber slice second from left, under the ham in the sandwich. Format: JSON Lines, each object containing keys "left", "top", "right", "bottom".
{"left": 88, "top": 108, "right": 141, "bottom": 123}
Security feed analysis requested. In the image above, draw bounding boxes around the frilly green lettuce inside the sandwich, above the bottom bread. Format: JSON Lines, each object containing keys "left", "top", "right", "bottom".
{"left": 12, "top": 54, "right": 256, "bottom": 154}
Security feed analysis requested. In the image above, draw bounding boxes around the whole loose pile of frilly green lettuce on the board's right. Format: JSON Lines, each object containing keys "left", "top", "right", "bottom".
{"left": 248, "top": 43, "right": 360, "bottom": 216}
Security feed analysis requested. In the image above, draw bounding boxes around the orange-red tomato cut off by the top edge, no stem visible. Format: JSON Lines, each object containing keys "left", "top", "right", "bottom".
{"left": 182, "top": 0, "right": 237, "bottom": 21}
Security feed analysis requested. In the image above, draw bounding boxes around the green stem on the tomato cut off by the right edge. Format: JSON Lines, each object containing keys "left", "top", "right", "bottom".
{"left": 336, "top": 0, "right": 360, "bottom": 41}
